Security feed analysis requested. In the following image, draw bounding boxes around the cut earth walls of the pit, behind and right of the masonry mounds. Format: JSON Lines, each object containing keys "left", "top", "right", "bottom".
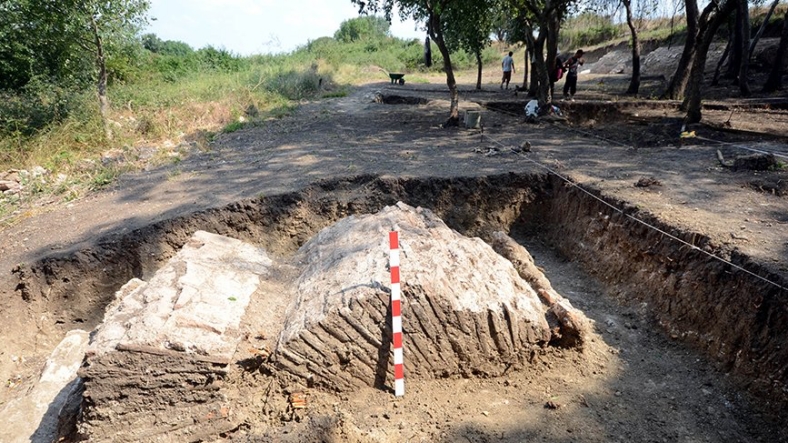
{"left": 6, "top": 174, "right": 788, "bottom": 434}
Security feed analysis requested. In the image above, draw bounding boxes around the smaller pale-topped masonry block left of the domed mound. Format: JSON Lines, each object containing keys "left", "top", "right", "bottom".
{"left": 79, "top": 232, "right": 271, "bottom": 441}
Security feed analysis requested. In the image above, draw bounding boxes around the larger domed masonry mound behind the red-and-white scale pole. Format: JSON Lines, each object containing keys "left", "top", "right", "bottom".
{"left": 275, "top": 203, "right": 583, "bottom": 390}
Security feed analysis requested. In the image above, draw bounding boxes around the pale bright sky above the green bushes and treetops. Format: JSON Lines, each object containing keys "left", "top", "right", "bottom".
{"left": 145, "top": 0, "right": 425, "bottom": 55}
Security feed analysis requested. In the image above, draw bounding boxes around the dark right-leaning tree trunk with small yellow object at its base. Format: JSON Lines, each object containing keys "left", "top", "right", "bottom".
{"left": 682, "top": 0, "right": 738, "bottom": 123}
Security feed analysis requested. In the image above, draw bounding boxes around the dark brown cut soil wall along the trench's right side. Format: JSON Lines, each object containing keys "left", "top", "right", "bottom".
{"left": 528, "top": 175, "right": 788, "bottom": 412}
